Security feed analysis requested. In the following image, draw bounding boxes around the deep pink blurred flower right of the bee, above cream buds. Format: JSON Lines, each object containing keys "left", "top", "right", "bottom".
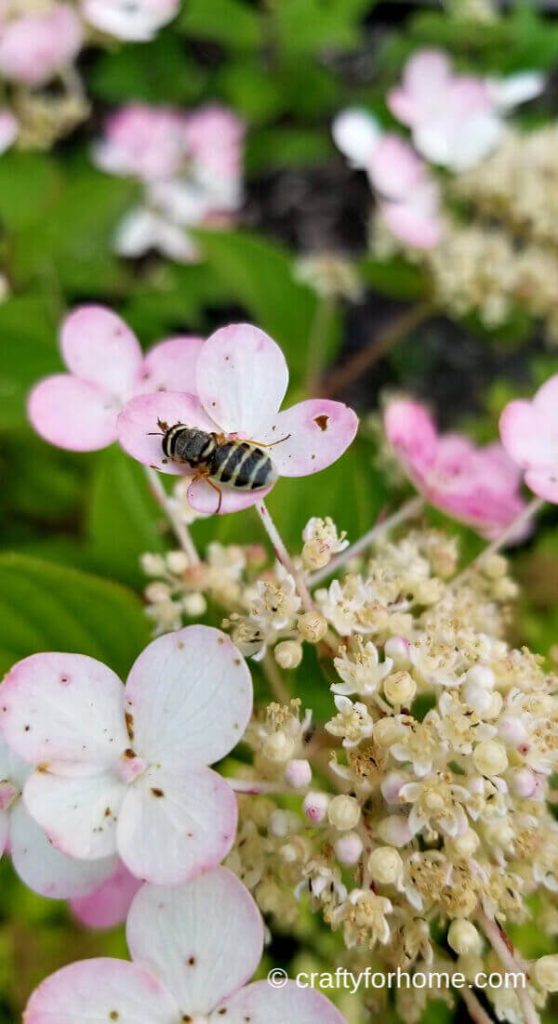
{"left": 384, "top": 399, "right": 525, "bottom": 540}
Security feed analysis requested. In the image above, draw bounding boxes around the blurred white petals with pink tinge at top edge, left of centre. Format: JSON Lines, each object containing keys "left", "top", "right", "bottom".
{"left": 81, "top": 0, "right": 180, "bottom": 42}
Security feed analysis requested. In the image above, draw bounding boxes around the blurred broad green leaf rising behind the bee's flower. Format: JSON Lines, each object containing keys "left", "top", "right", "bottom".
{"left": 196, "top": 231, "right": 340, "bottom": 380}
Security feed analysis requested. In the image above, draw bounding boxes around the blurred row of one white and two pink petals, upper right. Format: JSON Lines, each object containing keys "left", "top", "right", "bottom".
{"left": 333, "top": 109, "right": 442, "bottom": 249}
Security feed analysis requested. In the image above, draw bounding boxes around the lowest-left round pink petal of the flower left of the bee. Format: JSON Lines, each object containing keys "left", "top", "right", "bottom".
{"left": 28, "top": 374, "right": 121, "bottom": 452}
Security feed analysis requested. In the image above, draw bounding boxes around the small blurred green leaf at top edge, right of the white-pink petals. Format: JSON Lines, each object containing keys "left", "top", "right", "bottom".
{"left": 180, "top": 0, "right": 264, "bottom": 50}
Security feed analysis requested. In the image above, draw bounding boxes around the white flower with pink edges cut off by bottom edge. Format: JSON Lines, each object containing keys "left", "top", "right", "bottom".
{"left": 24, "top": 868, "right": 345, "bottom": 1024}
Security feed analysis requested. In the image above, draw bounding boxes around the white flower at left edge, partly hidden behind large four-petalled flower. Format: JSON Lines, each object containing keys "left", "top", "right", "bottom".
{"left": 0, "top": 735, "right": 117, "bottom": 899}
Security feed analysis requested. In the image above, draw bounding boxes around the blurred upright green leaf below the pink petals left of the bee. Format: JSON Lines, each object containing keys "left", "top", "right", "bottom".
{"left": 88, "top": 444, "right": 164, "bottom": 586}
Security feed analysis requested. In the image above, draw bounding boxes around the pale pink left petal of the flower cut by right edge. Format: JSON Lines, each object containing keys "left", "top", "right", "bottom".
{"left": 500, "top": 400, "right": 558, "bottom": 469}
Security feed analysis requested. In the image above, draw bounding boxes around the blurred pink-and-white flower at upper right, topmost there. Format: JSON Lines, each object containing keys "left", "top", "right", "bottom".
{"left": 388, "top": 50, "right": 544, "bottom": 171}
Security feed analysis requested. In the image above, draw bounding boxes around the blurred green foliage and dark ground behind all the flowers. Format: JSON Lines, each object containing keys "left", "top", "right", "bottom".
{"left": 0, "top": 0, "right": 558, "bottom": 1024}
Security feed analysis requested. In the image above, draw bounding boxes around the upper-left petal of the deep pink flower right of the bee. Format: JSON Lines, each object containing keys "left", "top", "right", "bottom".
{"left": 384, "top": 399, "right": 437, "bottom": 474}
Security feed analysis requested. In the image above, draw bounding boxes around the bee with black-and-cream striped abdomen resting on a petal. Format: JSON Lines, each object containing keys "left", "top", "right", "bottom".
{"left": 150, "top": 420, "right": 291, "bottom": 512}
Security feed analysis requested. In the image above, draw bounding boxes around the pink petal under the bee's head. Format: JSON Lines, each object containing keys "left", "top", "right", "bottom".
{"left": 117, "top": 391, "right": 216, "bottom": 476}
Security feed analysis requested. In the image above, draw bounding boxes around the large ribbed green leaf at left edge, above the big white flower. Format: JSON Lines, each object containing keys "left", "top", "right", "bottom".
{"left": 0, "top": 554, "right": 148, "bottom": 676}
